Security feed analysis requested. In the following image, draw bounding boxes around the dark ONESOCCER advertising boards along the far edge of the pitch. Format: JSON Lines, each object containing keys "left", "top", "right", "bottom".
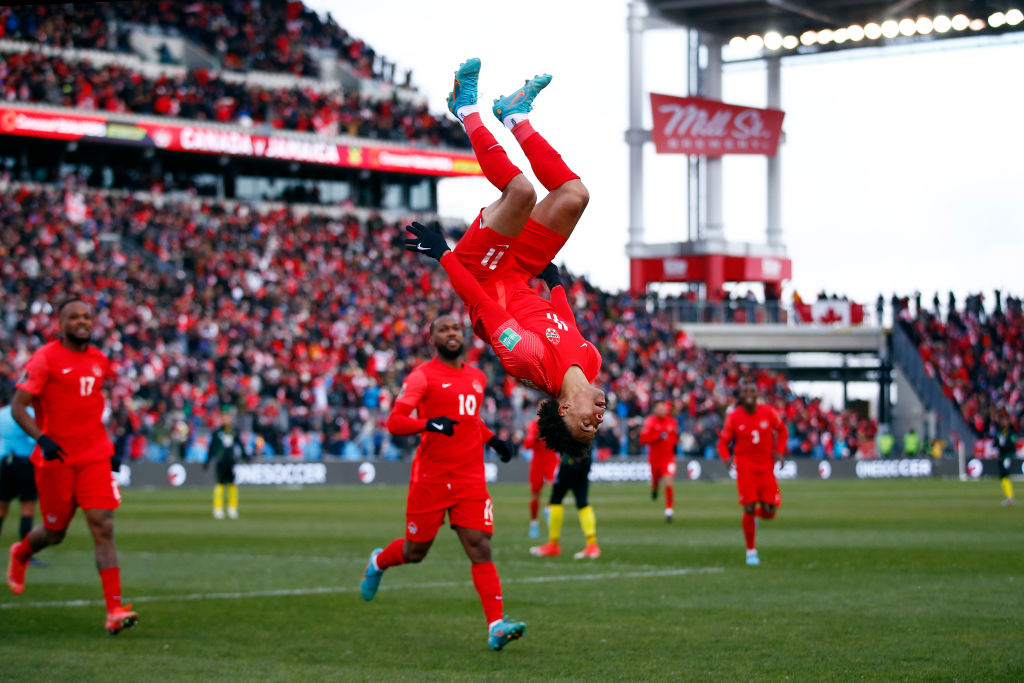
{"left": 108, "top": 458, "right": 978, "bottom": 488}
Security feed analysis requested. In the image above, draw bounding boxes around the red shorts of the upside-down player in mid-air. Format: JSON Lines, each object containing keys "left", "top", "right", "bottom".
{"left": 455, "top": 214, "right": 565, "bottom": 290}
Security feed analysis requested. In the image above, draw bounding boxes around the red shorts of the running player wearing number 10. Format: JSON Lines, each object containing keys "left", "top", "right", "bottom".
{"left": 406, "top": 483, "right": 495, "bottom": 543}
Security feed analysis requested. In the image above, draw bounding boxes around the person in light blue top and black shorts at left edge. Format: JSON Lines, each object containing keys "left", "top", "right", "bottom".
{"left": 0, "top": 405, "right": 46, "bottom": 566}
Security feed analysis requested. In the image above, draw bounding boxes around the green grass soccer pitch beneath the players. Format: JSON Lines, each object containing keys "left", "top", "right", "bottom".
{"left": 0, "top": 480, "right": 1024, "bottom": 681}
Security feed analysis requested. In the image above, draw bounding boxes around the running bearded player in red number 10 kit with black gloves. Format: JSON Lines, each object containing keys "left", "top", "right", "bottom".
{"left": 359, "top": 315, "right": 526, "bottom": 650}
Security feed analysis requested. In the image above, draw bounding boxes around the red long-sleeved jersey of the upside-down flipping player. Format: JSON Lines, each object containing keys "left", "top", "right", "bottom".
{"left": 441, "top": 254, "right": 601, "bottom": 396}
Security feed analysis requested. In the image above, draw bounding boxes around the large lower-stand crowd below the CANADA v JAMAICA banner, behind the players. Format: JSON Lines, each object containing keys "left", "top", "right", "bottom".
{"left": 0, "top": 185, "right": 876, "bottom": 458}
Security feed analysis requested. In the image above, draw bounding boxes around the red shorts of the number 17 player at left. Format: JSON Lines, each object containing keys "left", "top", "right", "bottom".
{"left": 36, "top": 458, "right": 121, "bottom": 531}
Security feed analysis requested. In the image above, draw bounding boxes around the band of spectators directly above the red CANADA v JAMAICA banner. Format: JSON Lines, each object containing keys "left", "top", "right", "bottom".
{"left": 0, "top": 52, "right": 469, "bottom": 147}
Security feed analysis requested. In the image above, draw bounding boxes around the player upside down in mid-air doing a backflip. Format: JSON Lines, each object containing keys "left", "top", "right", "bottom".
{"left": 406, "top": 58, "right": 605, "bottom": 456}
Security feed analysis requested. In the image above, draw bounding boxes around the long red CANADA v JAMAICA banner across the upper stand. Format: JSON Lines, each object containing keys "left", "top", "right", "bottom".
{"left": 0, "top": 106, "right": 482, "bottom": 176}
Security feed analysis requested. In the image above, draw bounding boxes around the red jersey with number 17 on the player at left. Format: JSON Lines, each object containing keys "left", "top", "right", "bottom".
{"left": 17, "top": 340, "right": 114, "bottom": 467}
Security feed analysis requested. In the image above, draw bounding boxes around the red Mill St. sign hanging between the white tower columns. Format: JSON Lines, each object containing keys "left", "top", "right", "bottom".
{"left": 650, "top": 92, "right": 785, "bottom": 157}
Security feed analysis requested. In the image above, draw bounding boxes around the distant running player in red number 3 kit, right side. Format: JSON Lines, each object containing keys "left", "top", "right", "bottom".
{"left": 718, "top": 381, "right": 788, "bottom": 566}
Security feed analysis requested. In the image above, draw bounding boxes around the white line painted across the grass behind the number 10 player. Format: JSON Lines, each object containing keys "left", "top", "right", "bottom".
{"left": 0, "top": 567, "right": 725, "bottom": 609}
